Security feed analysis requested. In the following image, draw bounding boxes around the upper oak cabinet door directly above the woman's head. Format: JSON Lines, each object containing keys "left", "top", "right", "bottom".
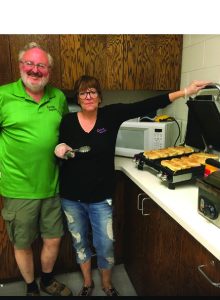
{"left": 60, "top": 34, "right": 123, "bottom": 90}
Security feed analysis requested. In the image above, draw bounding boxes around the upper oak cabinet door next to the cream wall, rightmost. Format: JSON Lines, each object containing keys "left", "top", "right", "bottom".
{"left": 123, "top": 34, "right": 183, "bottom": 90}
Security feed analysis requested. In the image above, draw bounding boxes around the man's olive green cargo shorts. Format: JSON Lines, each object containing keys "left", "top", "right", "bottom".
{"left": 2, "top": 197, "right": 64, "bottom": 249}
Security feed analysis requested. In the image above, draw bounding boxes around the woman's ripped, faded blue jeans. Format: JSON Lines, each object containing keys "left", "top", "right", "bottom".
{"left": 61, "top": 199, "right": 114, "bottom": 269}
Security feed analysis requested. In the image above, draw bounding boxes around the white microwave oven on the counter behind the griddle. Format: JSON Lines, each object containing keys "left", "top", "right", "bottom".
{"left": 115, "top": 121, "right": 180, "bottom": 157}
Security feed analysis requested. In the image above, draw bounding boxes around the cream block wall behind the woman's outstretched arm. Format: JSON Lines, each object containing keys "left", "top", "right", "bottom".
{"left": 163, "top": 34, "right": 220, "bottom": 142}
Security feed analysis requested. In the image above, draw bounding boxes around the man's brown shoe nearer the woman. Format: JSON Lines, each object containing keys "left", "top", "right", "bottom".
{"left": 40, "top": 279, "right": 73, "bottom": 296}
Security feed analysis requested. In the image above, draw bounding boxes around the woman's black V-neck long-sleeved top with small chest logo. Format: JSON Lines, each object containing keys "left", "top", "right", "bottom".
{"left": 59, "top": 94, "right": 170, "bottom": 203}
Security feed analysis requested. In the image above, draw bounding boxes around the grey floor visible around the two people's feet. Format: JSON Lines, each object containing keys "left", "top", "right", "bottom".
{"left": 0, "top": 265, "right": 137, "bottom": 296}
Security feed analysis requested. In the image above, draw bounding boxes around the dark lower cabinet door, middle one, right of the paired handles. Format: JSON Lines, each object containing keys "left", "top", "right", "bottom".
{"left": 142, "top": 198, "right": 181, "bottom": 296}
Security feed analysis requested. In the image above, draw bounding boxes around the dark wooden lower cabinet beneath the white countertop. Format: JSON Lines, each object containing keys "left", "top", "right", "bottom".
{"left": 119, "top": 173, "right": 220, "bottom": 296}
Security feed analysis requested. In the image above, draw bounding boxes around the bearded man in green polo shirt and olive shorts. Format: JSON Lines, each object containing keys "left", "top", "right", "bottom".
{"left": 0, "top": 43, "right": 72, "bottom": 296}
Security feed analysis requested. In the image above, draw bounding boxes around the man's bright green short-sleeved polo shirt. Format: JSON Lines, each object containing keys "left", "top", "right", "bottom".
{"left": 0, "top": 79, "right": 68, "bottom": 199}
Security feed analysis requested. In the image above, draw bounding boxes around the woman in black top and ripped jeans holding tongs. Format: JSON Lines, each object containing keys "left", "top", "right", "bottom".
{"left": 55, "top": 76, "right": 209, "bottom": 296}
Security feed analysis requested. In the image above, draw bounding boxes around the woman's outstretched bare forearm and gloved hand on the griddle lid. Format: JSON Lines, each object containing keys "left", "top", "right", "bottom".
{"left": 169, "top": 80, "right": 211, "bottom": 102}
